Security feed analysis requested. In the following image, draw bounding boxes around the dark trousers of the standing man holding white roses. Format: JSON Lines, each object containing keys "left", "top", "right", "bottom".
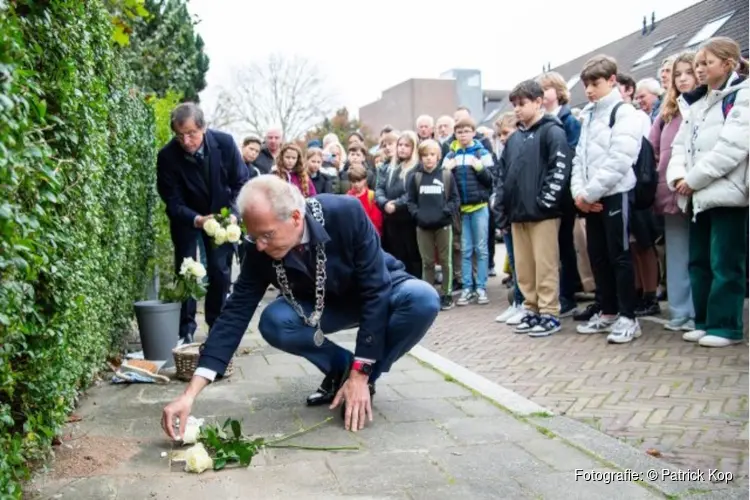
{"left": 171, "top": 224, "right": 234, "bottom": 338}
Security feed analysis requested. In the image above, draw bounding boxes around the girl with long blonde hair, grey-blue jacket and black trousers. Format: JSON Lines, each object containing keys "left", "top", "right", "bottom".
{"left": 375, "top": 131, "right": 422, "bottom": 278}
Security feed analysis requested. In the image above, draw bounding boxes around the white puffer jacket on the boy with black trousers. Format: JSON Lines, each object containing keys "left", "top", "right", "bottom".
{"left": 570, "top": 88, "right": 643, "bottom": 203}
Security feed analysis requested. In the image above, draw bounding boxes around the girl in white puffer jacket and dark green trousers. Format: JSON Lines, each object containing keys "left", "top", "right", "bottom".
{"left": 666, "top": 37, "right": 750, "bottom": 347}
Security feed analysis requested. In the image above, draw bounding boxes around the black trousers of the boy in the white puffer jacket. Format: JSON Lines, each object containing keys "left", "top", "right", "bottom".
{"left": 586, "top": 193, "right": 636, "bottom": 319}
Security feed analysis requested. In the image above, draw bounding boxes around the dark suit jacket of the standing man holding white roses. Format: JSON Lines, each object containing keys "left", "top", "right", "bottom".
{"left": 156, "top": 130, "right": 248, "bottom": 228}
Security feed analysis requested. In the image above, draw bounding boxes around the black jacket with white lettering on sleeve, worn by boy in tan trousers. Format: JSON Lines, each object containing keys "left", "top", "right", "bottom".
{"left": 495, "top": 114, "right": 573, "bottom": 229}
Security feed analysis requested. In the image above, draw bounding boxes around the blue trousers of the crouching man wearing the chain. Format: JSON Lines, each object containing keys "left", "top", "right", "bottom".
{"left": 258, "top": 279, "right": 440, "bottom": 382}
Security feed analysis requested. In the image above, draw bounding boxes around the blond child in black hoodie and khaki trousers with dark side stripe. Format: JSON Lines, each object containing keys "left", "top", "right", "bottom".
{"left": 406, "top": 139, "right": 459, "bottom": 311}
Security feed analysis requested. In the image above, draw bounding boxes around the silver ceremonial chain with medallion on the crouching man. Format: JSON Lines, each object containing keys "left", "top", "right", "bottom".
{"left": 273, "top": 198, "right": 327, "bottom": 347}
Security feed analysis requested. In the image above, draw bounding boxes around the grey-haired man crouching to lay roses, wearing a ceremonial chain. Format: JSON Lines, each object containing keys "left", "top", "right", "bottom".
{"left": 162, "top": 175, "right": 440, "bottom": 439}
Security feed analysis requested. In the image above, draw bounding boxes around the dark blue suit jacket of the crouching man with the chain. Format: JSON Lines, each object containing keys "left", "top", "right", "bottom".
{"left": 198, "top": 194, "right": 410, "bottom": 374}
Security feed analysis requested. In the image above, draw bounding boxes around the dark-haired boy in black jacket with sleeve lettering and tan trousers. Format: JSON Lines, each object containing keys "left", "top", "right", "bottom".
{"left": 496, "top": 80, "right": 573, "bottom": 337}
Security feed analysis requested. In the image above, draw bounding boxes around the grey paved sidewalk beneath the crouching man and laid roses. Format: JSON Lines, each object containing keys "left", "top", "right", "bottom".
{"left": 28, "top": 324, "right": 747, "bottom": 500}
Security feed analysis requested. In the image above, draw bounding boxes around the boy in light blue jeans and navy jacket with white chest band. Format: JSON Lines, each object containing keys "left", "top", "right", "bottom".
{"left": 443, "top": 117, "right": 494, "bottom": 306}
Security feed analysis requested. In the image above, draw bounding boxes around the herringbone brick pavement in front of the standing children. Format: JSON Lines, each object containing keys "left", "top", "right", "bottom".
{"left": 422, "top": 245, "right": 748, "bottom": 478}
